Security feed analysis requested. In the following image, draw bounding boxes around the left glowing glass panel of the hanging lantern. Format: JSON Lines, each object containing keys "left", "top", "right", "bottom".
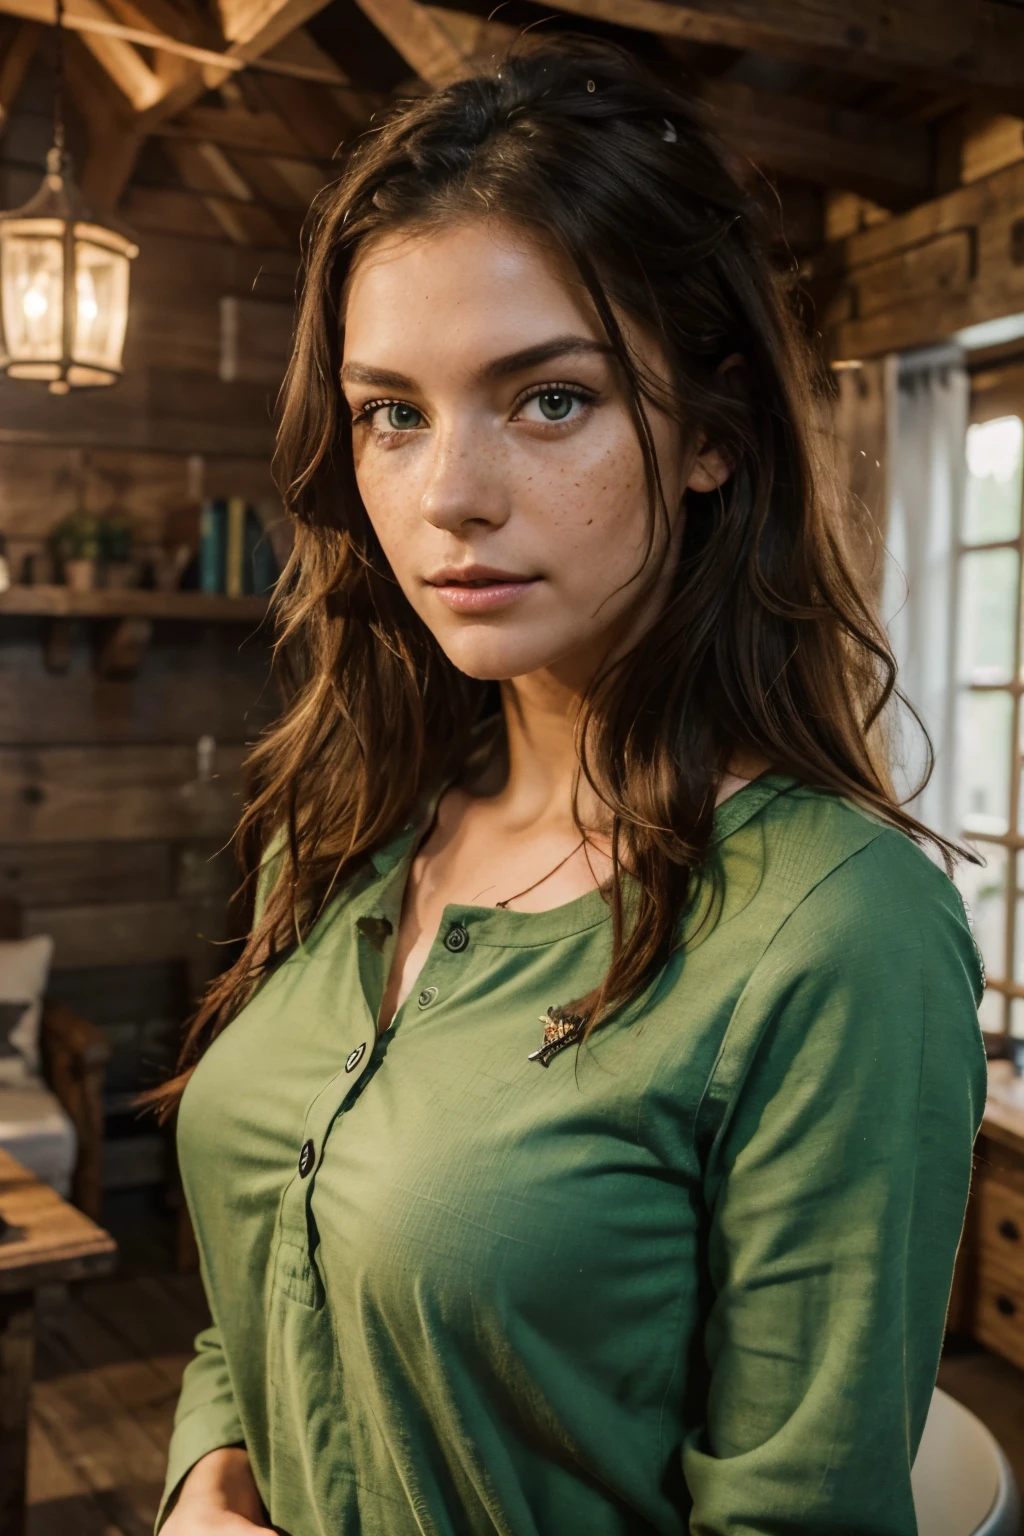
{"left": 0, "top": 226, "right": 64, "bottom": 368}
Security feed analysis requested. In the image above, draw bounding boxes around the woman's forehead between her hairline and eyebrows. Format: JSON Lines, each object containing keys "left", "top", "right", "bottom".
{"left": 344, "top": 220, "right": 605, "bottom": 372}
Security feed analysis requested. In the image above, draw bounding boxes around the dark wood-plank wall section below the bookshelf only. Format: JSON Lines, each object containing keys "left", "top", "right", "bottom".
{"left": 0, "top": 617, "right": 273, "bottom": 1184}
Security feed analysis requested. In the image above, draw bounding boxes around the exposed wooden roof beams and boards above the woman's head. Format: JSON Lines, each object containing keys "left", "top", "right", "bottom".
{"left": 0, "top": 0, "right": 1024, "bottom": 264}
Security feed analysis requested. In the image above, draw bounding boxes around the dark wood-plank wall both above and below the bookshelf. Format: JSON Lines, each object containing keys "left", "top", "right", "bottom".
{"left": 0, "top": 213, "right": 295, "bottom": 1186}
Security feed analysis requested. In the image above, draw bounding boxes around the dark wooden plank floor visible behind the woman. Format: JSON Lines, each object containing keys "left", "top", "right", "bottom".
{"left": 28, "top": 1197, "right": 1024, "bottom": 1536}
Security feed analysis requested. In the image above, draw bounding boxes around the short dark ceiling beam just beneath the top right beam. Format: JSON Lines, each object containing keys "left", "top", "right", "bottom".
{"left": 695, "top": 80, "right": 933, "bottom": 209}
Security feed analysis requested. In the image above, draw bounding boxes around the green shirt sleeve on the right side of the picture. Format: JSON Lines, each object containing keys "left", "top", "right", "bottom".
{"left": 683, "top": 833, "right": 986, "bottom": 1536}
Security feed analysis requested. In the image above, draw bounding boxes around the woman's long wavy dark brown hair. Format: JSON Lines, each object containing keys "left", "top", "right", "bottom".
{"left": 149, "top": 35, "right": 947, "bottom": 1114}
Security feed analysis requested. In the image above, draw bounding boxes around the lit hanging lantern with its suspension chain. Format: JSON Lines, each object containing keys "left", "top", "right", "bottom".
{"left": 0, "top": 3, "right": 138, "bottom": 395}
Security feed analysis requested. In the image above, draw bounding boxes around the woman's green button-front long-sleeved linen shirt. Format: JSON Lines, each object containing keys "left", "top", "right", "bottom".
{"left": 157, "top": 774, "right": 986, "bottom": 1536}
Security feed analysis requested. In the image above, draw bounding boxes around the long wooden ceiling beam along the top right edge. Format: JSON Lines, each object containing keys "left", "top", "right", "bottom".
{"left": 525, "top": 0, "right": 1024, "bottom": 100}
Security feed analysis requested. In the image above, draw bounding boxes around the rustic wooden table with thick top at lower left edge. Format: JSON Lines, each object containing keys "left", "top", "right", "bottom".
{"left": 0, "top": 1150, "right": 117, "bottom": 1536}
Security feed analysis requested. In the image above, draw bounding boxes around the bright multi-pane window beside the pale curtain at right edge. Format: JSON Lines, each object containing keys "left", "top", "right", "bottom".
{"left": 955, "top": 415, "right": 1024, "bottom": 1037}
